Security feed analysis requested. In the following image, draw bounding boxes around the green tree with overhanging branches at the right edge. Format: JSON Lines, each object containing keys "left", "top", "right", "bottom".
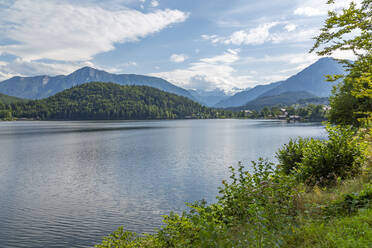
{"left": 310, "top": 0, "right": 372, "bottom": 126}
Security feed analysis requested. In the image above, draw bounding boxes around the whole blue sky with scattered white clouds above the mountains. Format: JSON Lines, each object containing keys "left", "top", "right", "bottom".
{"left": 0, "top": 0, "right": 358, "bottom": 93}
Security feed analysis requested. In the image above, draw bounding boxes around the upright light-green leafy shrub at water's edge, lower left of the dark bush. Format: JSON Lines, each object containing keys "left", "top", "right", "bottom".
{"left": 218, "top": 159, "right": 299, "bottom": 247}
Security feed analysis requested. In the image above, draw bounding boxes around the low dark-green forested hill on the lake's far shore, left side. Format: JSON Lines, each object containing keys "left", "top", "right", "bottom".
{"left": 0, "top": 82, "right": 215, "bottom": 120}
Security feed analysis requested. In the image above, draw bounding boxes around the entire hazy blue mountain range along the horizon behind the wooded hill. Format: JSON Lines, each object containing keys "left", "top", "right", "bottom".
{"left": 0, "top": 58, "right": 345, "bottom": 108}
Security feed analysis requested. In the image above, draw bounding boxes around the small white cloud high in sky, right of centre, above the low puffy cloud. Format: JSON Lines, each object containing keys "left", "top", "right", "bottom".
{"left": 224, "top": 22, "right": 279, "bottom": 45}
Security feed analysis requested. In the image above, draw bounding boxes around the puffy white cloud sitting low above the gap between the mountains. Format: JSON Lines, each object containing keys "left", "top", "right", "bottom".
{"left": 151, "top": 49, "right": 255, "bottom": 93}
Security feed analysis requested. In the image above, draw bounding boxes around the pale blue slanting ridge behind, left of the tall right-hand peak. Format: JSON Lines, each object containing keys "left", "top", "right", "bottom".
{"left": 213, "top": 82, "right": 281, "bottom": 108}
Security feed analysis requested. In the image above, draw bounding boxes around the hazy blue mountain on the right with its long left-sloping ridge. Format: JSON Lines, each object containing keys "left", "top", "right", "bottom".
{"left": 215, "top": 58, "right": 345, "bottom": 107}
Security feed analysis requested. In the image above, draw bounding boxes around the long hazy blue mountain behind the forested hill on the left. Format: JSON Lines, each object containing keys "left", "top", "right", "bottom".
{"left": 0, "top": 67, "right": 196, "bottom": 100}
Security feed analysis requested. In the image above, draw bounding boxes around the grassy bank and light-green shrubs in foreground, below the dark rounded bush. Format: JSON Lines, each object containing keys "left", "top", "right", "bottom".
{"left": 96, "top": 128, "right": 372, "bottom": 248}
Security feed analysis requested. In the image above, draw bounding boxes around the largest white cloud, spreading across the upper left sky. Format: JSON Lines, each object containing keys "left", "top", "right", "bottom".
{"left": 0, "top": 0, "right": 188, "bottom": 61}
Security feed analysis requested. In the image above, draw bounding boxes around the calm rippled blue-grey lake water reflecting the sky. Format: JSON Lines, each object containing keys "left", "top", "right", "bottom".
{"left": 0, "top": 120, "right": 325, "bottom": 248}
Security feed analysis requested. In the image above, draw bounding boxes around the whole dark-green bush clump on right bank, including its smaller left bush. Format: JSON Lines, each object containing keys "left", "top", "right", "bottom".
{"left": 277, "top": 126, "right": 365, "bottom": 186}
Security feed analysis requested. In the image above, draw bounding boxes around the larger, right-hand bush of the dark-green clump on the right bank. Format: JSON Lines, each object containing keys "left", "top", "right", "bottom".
{"left": 296, "top": 126, "right": 365, "bottom": 186}
